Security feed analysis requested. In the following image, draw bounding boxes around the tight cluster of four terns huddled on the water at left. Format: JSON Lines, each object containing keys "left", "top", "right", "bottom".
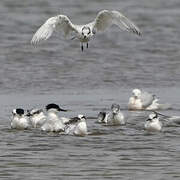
{"left": 11, "top": 103, "right": 87, "bottom": 136}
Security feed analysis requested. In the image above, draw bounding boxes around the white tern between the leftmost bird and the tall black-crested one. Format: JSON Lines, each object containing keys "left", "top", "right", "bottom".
{"left": 27, "top": 109, "right": 46, "bottom": 128}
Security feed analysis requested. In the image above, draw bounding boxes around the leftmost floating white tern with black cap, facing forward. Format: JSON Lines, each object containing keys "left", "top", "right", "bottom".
{"left": 11, "top": 108, "right": 30, "bottom": 130}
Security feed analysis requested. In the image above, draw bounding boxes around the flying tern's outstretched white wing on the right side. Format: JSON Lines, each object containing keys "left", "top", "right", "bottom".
{"left": 92, "top": 10, "right": 141, "bottom": 35}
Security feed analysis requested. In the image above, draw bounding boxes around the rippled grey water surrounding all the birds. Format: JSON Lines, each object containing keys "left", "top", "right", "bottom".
{"left": 0, "top": 0, "right": 180, "bottom": 180}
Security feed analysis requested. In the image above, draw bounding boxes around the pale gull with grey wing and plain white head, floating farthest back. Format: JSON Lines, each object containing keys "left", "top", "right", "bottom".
{"left": 128, "top": 89, "right": 159, "bottom": 110}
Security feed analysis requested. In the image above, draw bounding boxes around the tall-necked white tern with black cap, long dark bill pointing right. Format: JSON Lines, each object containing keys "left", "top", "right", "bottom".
{"left": 41, "top": 104, "right": 67, "bottom": 132}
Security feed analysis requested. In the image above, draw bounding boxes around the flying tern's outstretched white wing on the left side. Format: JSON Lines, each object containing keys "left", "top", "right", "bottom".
{"left": 31, "top": 15, "right": 77, "bottom": 45}
